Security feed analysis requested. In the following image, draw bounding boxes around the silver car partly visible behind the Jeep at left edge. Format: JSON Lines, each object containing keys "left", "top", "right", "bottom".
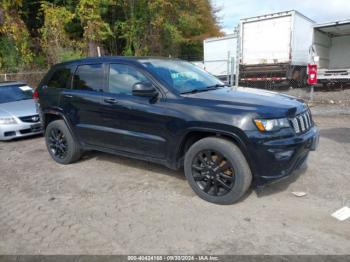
{"left": 0, "top": 82, "right": 42, "bottom": 140}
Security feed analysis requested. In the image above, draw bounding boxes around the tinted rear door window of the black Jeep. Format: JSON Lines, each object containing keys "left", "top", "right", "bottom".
{"left": 73, "top": 64, "right": 103, "bottom": 91}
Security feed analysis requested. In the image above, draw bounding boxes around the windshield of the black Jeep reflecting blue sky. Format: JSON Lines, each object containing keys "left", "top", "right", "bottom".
{"left": 140, "top": 59, "right": 224, "bottom": 94}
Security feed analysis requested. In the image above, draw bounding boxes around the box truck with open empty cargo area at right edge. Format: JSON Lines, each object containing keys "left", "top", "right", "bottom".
{"left": 310, "top": 20, "right": 350, "bottom": 86}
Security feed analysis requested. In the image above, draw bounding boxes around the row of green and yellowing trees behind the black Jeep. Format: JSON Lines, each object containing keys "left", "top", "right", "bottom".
{"left": 0, "top": 0, "right": 221, "bottom": 70}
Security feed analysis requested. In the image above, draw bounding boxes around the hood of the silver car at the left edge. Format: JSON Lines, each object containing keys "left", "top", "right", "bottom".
{"left": 0, "top": 99, "right": 38, "bottom": 117}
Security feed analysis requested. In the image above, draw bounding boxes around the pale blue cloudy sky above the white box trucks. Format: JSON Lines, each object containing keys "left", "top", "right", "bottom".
{"left": 212, "top": 0, "right": 350, "bottom": 33}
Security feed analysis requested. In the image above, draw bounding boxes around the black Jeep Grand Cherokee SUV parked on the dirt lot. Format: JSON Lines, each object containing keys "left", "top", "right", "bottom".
{"left": 35, "top": 57, "right": 319, "bottom": 204}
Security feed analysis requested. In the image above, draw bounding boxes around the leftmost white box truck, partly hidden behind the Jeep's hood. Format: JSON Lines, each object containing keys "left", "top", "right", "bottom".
{"left": 203, "top": 33, "right": 238, "bottom": 80}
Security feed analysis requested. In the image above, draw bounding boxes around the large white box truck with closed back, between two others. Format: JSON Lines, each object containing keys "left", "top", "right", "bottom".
{"left": 239, "top": 10, "right": 315, "bottom": 88}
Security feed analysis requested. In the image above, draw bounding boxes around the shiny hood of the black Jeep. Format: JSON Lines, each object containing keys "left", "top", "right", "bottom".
{"left": 185, "top": 87, "right": 307, "bottom": 118}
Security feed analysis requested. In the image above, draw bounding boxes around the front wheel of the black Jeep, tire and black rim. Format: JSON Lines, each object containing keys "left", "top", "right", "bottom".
{"left": 184, "top": 137, "right": 252, "bottom": 205}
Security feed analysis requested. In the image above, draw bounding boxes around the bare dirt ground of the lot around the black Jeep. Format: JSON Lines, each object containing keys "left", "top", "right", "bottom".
{"left": 0, "top": 113, "right": 350, "bottom": 254}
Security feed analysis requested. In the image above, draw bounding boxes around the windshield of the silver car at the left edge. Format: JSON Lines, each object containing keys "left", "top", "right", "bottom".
{"left": 0, "top": 85, "right": 33, "bottom": 104}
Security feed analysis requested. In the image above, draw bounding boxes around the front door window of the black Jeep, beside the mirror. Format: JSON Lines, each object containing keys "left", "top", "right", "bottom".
{"left": 108, "top": 64, "right": 149, "bottom": 95}
